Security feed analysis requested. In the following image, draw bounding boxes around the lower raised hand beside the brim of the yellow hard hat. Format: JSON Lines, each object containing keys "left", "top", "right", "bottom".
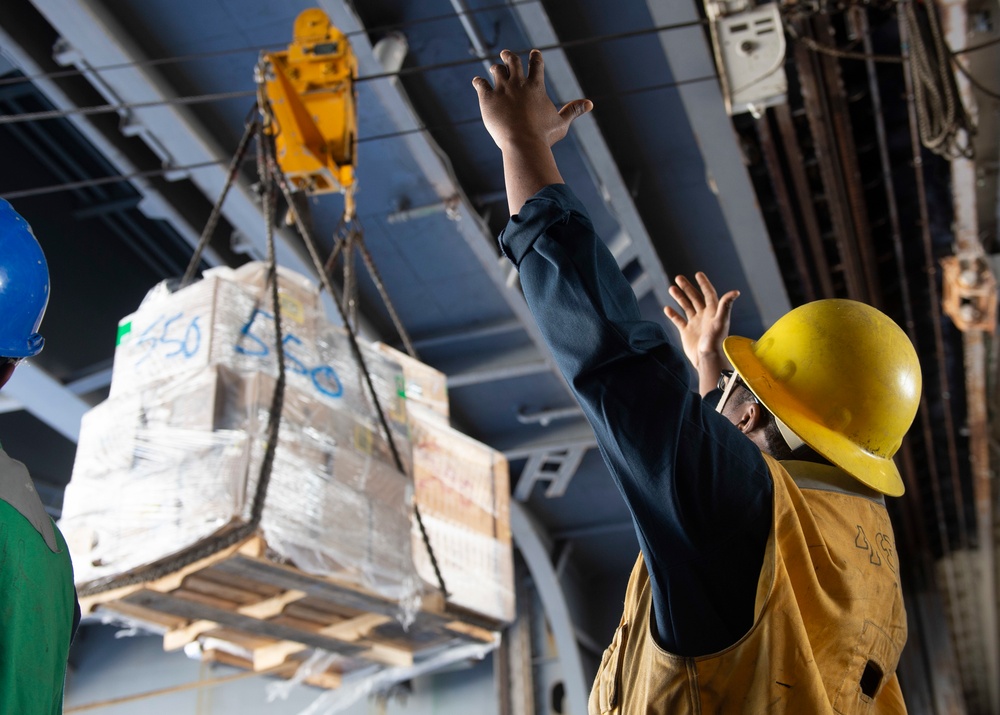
{"left": 663, "top": 271, "right": 740, "bottom": 380}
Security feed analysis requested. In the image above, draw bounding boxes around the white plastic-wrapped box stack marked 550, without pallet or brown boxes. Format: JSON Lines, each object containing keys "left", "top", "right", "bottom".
{"left": 63, "top": 263, "right": 417, "bottom": 602}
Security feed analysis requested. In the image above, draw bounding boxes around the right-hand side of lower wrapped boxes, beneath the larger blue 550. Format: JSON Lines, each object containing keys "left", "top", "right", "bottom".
{"left": 237, "top": 375, "right": 415, "bottom": 600}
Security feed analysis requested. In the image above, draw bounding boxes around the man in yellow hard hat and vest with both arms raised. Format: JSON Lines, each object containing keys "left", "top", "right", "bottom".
{"left": 473, "top": 51, "right": 921, "bottom": 715}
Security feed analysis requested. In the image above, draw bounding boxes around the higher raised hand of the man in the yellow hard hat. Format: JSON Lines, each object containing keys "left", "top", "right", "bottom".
{"left": 472, "top": 50, "right": 594, "bottom": 152}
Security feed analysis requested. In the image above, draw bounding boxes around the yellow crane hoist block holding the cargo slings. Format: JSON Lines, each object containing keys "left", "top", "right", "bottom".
{"left": 259, "top": 8, "right": 358, "bottom": 221}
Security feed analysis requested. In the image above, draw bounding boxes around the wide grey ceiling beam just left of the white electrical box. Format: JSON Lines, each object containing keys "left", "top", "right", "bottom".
{"left": 646, "top": 0, "right": 791, "bottom": 328}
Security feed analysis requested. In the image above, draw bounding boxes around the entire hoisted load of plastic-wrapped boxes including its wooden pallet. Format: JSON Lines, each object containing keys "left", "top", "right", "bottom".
{"left": 60, "top": 264, "right": 514, "bottom": 704}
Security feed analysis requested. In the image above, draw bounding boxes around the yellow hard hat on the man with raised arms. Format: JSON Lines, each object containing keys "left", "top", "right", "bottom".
{"left": 724, "top": 299, "right": 921, "bottom": 496}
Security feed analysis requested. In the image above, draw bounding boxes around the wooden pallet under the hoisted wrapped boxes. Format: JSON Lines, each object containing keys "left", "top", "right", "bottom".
{"left": 80, "top": 536, "right": 499, "bottom": 688}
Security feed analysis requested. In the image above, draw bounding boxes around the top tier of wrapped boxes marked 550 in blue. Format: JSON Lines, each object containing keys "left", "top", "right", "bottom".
{"left": 110, "top": 263, "right": 405, "bottom": 428}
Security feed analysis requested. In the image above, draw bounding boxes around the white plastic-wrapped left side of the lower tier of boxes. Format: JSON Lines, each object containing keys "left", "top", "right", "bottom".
{"left": 60, "top": 371, "right": 250, "bottom": 581}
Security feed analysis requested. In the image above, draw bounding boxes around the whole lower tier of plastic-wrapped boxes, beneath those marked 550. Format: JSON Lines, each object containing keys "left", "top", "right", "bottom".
{"left": 60, "top": 367, "right": 414, "bottom": 599}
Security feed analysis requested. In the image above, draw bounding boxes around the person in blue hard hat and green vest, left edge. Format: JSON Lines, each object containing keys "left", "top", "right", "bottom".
{"left": 0, "top": 199, "right": 80, "bottom": 715}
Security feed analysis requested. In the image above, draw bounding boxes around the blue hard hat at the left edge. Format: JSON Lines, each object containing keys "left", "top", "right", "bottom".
{"left": 0, "top": 199, "right": 49, "bottom": 358}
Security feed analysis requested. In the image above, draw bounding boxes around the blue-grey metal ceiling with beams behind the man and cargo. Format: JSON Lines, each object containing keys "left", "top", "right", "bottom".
{"left": 0, "top": 0, "right": 1000, "bottom": 713}
